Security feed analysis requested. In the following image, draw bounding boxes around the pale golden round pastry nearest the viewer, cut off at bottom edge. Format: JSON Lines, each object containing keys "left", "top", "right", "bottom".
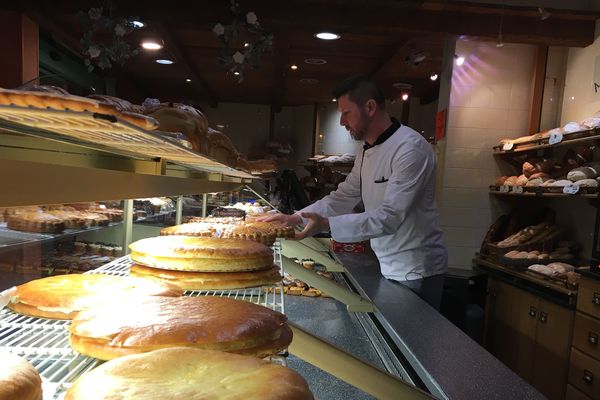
{"left": 65, "top": 347, "right": 313, "bottom": 400}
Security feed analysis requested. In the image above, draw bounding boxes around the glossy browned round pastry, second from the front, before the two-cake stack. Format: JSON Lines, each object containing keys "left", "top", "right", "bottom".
{"left": 69, "top": 296, "right": 292, "bottom": 360}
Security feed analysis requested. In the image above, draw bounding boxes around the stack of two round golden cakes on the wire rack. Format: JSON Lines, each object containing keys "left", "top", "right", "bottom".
{"left": 129, "top": 236, "right": 281, "bottom": 290}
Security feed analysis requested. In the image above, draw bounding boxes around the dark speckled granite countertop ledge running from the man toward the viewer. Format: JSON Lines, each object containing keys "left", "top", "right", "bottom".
{"left": 337, "top": 253, "right": 545, "bottom": 400}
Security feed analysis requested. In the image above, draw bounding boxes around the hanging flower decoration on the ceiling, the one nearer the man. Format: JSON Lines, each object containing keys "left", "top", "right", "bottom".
{"left": 213, "top": 0, "right": 273, "bottom": 82}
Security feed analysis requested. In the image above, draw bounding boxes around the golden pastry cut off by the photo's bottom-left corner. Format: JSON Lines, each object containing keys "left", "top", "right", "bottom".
{"left": 0, "top": 350, "right": 42, "bottom": 400}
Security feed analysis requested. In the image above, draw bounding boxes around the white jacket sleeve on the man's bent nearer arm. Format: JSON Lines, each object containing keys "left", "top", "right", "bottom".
{"left": 329, "top": 147, "right": 435, "bottom": 242}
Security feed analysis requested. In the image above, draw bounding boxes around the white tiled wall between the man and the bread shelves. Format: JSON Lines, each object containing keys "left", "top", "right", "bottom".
{"left": 439, "top": 42, "right": 535, "bottom": 268}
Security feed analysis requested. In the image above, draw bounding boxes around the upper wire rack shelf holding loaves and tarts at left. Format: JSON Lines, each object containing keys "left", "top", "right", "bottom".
{"left": 0, "top": 105, "right": 255, "bottom": 179}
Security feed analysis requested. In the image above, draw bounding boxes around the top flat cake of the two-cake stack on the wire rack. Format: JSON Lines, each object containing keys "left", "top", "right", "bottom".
{"left": 129, "top": 236, "right": 273, "bottom": 272}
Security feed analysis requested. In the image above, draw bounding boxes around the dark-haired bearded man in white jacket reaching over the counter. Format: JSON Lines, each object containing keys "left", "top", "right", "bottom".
{"left": 269, "top": 75, "right": 447, "bottom": 309}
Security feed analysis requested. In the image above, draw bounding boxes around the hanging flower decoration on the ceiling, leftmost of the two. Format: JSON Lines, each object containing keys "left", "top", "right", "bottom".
{"left": 77, "top": 1, "right": 139, "bottom": 72}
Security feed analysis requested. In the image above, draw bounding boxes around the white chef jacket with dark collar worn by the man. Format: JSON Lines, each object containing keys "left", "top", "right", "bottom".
{"left": 300, "top": 120, "right": 448, "bottom": 281}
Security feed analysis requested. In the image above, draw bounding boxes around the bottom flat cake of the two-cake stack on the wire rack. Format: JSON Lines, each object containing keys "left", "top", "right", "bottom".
{"left": 130, "top": 264, "right": 281, "bottom": 290}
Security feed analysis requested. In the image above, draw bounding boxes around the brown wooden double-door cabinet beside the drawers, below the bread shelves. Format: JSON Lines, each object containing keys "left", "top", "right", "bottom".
{"left": 485, "top": 278, "right": 574, "bottom": 400}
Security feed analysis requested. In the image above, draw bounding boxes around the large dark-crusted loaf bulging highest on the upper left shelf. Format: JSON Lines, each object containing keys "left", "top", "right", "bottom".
{"left": 146, "top": 103, "right": 208, "bottom": 153}
